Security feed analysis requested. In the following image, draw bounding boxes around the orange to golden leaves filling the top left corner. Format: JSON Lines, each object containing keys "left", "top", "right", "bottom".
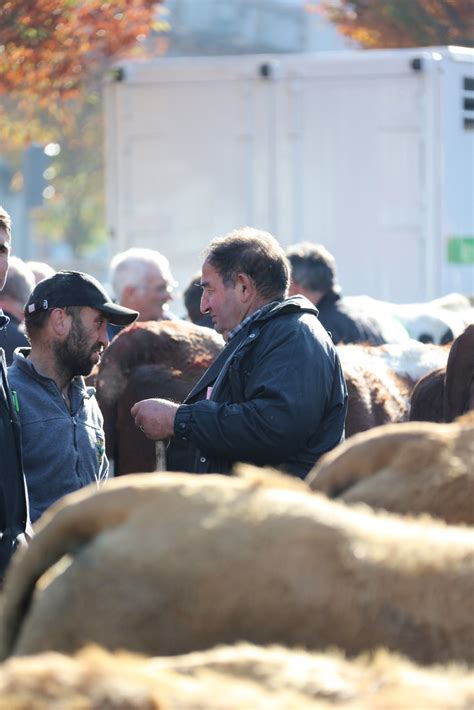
{"left": 0, "top": 0, "right": 162, "bottom": 147}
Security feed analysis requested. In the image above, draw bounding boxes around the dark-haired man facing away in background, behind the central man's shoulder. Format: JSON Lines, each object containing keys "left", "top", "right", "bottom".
{"left": 286, "top": 242, "right": 386, "bottom": 345}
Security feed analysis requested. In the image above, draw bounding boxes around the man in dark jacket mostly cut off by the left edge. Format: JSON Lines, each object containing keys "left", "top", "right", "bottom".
{"left": 0, "top": 207, "right": 29, "bottom": 581}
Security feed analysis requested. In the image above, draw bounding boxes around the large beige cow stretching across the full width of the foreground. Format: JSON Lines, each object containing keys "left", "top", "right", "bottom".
{"left": 2, "top": 467, "right": 474, "bottom": 663}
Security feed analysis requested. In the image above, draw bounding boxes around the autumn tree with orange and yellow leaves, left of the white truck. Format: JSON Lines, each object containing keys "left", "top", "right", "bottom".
{"left": 0, "top": 0, "right": 164, "bottom": 253}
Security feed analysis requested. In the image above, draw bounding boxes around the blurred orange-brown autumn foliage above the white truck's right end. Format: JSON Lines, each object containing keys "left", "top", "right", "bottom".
{"left": 318, "top": 0, "right": 474, "bottom": 48}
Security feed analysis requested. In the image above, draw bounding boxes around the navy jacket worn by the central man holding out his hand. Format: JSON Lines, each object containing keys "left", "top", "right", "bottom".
{"left": 169, "top": 296, "right": 347, "bottom": 478}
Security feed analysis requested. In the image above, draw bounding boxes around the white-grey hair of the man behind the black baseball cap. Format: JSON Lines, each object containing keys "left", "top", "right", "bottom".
{"left": 110, "top": 247, "right": 177, "bottom": 302}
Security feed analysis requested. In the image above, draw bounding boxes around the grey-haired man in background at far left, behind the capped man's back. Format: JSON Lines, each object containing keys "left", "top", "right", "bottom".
{"left": 0, "top": 256, "right": 35, "bottom": 365}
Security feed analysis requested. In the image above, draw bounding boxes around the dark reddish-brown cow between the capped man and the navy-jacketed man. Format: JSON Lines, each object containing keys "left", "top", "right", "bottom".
{"left": 96, "top": 320, "right": 224, "bottom": 475}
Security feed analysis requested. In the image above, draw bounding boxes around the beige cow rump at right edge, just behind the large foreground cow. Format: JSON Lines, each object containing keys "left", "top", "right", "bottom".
{"left": 306, "top": 413, "right": 474, "bottom": 525}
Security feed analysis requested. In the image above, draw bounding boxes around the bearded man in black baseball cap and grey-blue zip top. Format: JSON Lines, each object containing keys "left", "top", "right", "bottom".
{"left": 9, "top": 271, "right": 138, "bottom": 522}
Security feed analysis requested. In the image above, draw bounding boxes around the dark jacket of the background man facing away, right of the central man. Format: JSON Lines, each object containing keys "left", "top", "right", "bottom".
{"left": 317, "top": 291, "right": 386, "bottom": 345}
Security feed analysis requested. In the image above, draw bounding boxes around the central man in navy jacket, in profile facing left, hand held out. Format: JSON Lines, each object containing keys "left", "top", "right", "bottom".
{"left": 132, "top": 228, "right": 347, "bottom": 478}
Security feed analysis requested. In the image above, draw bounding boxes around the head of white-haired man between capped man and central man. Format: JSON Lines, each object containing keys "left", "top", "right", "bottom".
{"left": 110, "top": 248, "right": 176, "bottom": 321}
